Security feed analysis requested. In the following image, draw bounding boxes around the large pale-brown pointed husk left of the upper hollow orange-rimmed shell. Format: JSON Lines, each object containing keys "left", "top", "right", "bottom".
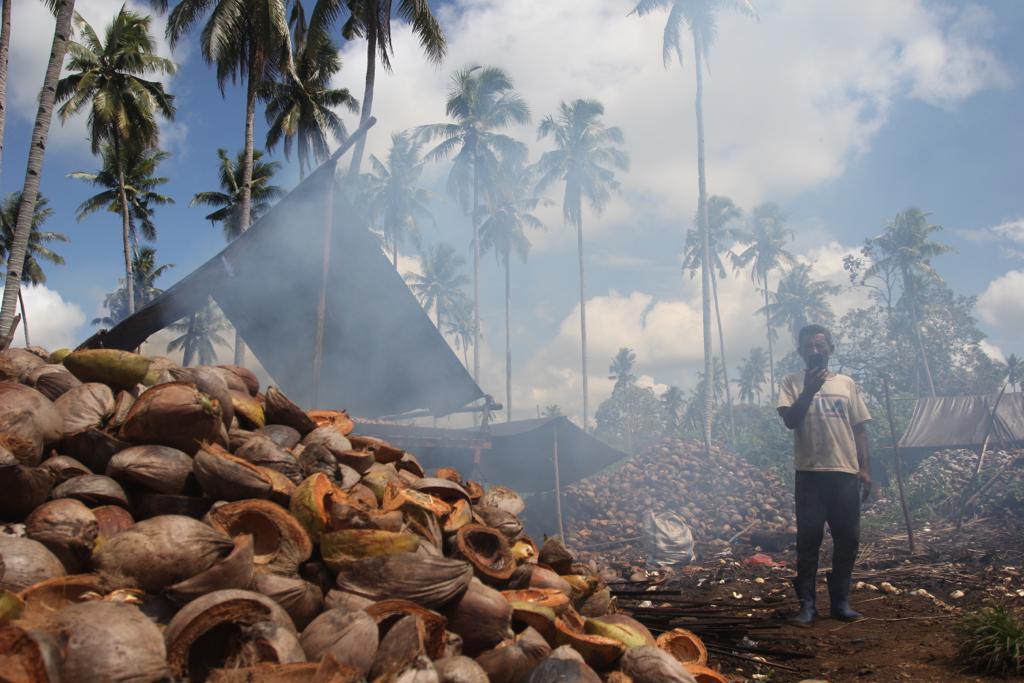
{"left": 93, "top": 515, "right": 234, "bottom": 593}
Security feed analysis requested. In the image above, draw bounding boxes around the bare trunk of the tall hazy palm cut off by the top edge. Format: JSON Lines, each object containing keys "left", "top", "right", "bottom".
{"left": 693, "top": 32, "right": 715, "bottom": 457}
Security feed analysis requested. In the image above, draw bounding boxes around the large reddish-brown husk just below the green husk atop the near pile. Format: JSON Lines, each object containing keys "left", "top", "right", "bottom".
{"left": 120, "top": 382, "right": 222, "bottom": 454}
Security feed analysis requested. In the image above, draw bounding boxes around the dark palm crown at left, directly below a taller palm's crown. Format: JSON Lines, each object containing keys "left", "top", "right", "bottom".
{"left": 68, "top": 144, "right": 174, "bottom": 252}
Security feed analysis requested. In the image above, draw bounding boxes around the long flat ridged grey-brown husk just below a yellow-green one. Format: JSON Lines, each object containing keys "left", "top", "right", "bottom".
{"left": 338, "top": 553, "right": 473, "bottom": 610}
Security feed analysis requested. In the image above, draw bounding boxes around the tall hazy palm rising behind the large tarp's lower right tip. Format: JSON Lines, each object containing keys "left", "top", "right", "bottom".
{"left": 417, "top": 65, "right": 529, "bottom": 381}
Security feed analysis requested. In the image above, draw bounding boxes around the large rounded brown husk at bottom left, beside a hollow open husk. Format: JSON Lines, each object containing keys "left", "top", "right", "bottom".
{"left": 52, "top": 601, "right": 168, "bottom": 683}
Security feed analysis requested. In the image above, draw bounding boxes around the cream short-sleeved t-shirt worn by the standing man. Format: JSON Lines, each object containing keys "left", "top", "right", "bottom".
{"left": 778, "top": 372, "right": 871, "bottom": 474}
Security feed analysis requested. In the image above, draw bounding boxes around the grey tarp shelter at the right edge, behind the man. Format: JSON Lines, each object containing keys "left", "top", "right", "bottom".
{"left": 899, "top": 393, "right": 1024, "bottom": 450}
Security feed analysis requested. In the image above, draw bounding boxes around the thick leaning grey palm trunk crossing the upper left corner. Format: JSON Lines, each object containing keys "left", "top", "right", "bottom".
{"left": 0, "top": 0, "right": 75, "bottom": 338}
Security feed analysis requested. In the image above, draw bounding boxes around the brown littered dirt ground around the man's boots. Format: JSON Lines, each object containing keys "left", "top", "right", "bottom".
{"left": 621, "top": 519, "right": 1024, "bottom": 683}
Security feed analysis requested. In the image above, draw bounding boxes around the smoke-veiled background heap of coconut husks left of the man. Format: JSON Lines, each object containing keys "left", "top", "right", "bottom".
{"left": 562, "top": 439, "right": 796, "bottom": 568}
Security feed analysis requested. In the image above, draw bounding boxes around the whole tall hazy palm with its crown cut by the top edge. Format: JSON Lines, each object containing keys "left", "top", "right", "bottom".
{"left": 633, "top": 0, "right": 757, "bottom": 455}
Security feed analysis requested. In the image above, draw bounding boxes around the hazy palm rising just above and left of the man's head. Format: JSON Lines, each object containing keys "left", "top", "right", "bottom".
{"left": 732, "top": 202, "right": 797, "bottom": 400}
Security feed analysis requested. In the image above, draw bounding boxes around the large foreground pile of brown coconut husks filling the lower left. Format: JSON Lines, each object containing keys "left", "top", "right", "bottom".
{"left": 0, "top": 349, "right": 724, "bottom": 683}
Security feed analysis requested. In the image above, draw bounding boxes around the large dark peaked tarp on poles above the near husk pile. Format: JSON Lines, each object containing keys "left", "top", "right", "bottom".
{"left": 82, "top": 120, "right": 483, "bottom": 418}
